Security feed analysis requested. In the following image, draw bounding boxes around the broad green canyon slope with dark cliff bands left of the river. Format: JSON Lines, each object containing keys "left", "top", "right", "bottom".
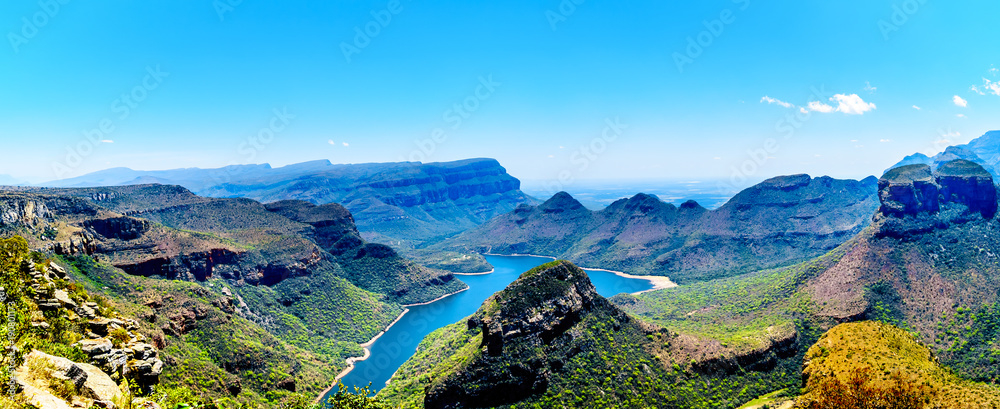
{"left": 0, "top": 185, "right": 464, "bottom": 403}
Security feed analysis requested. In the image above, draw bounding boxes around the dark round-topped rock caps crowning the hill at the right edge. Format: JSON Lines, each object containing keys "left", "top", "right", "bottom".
{"left": 878, "top": 159, "right": 997, "bottom": 218}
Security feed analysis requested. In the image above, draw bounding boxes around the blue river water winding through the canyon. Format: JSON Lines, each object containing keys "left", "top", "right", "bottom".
{"left": 324, "top": 256, "right": 653, "bottom": 400}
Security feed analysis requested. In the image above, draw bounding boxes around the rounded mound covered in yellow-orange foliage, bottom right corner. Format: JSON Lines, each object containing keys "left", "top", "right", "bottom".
{"left": 799, "top": 321, "right": 1000, "bottom": 409}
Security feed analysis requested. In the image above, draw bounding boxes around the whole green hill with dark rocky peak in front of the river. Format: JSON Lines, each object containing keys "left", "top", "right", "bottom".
{"left": 378, "top": 261, "right": 793, "bottom": 408}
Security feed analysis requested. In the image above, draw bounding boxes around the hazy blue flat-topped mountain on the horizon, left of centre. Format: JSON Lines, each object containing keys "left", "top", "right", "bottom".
{"left": 44, "top": 159, "right": 533, "bottom": 249}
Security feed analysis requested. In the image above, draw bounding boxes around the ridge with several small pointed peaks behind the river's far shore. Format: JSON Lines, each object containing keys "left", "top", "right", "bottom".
{"left": 434, "top": 175, "right": 879, "bottom": 283}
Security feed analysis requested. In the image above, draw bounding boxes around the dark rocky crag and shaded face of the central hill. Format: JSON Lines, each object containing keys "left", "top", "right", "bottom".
{"left": 424, "top": 261, "right": 634, "bottom": 409}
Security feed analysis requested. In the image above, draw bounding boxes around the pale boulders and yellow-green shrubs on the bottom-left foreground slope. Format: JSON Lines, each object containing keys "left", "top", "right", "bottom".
{"left": 0, "top": 237, "right": 165, "bottom": 408}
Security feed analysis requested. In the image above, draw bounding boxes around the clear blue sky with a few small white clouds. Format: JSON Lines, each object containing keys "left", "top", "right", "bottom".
{"left": 0, "top": 0, "right": 1000, "bottom": 184}
